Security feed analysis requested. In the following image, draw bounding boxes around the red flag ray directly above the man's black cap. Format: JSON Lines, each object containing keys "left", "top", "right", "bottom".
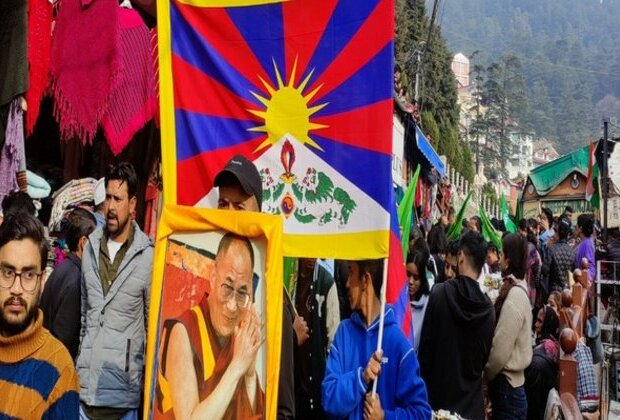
{"left": 177, "top": 136, "right": 268, "bottom": 206}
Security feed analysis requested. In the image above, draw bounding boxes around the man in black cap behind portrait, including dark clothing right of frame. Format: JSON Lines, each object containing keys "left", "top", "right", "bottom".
{"left": 214, "top": 155, "right": 295, "bottom": 419}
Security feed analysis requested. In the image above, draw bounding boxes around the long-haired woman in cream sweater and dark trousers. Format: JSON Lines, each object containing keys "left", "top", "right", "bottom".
{"left": 484, "top": 233, "right": 532, "bottom": 420}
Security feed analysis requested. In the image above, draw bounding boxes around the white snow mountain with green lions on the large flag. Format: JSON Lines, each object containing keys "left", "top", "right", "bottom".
{"left": 197, "top": 135, "right": 389, "bottom": 234}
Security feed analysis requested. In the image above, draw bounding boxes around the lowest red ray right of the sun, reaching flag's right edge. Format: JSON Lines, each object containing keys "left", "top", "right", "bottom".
{"left": 312, "top": 99, "right": 393, "bottom": 154}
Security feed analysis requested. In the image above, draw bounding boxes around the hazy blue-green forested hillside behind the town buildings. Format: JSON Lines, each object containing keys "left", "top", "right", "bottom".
{"left": 434, "top": 0, "right": 620, "bottom": 153}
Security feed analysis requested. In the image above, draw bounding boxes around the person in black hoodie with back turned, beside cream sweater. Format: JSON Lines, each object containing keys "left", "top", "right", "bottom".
{"left": 418, "top": 231, "right": 495, "bottom": 420}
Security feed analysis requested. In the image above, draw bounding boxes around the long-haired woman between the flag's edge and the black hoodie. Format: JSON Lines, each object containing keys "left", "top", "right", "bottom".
{"left": 406, "top": 240, "right": 431, "bottom": 352}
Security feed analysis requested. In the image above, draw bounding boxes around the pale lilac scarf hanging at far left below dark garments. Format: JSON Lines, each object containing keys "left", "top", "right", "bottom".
{"left": 0, "top": 97, "right": 24, "bottom": 202}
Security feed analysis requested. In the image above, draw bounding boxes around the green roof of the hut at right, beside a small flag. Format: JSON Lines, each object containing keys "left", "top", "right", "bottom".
{"left": 528, "top": 145, "right": 590, "bottom": 195}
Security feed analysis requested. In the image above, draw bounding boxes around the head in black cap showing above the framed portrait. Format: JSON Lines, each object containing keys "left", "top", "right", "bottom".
{"left": 214, "top": 155, "right": 263, "bottom": 212}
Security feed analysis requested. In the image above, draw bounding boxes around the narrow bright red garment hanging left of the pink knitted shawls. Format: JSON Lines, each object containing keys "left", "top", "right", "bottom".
{"left": 26, "top": 0, "right": 52, "bottom": 135}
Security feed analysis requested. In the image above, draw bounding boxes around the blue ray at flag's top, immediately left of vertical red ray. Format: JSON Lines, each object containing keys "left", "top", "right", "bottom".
{"left": 226, "top": 4, "right": 287, "bottom": 88}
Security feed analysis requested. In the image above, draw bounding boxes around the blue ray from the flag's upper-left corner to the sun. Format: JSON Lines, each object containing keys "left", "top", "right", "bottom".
{"left": 170, "top": 2, "right": 261, "bottom": 105}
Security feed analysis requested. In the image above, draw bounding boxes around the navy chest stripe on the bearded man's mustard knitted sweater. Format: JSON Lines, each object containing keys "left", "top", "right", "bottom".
{"left": 0, "top": 359, "right": 60, "bottom": 400}
